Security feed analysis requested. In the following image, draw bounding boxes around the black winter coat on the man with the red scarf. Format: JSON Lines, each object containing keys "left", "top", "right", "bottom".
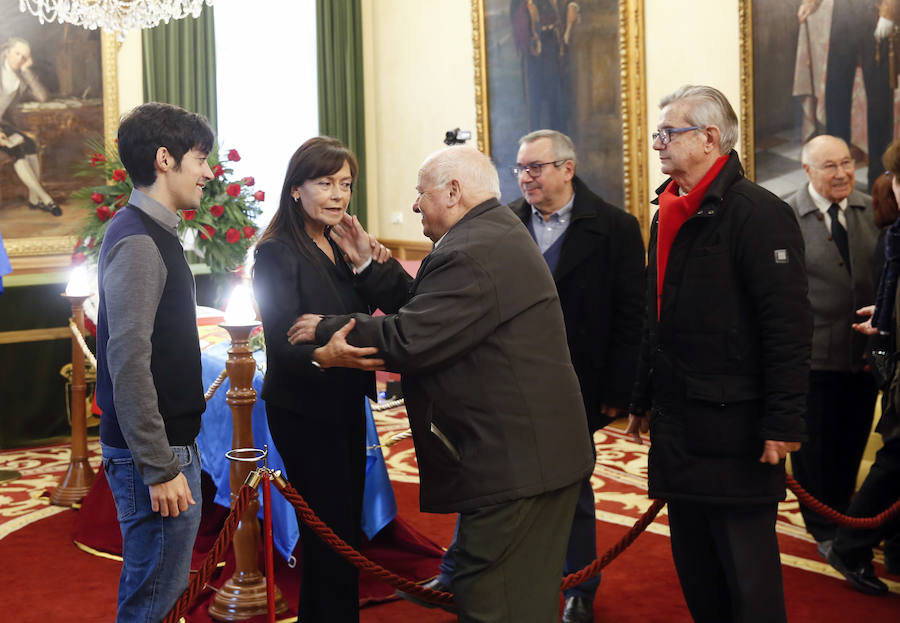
{"left": 632, "top": 151, "right": 812, "bottom": 503}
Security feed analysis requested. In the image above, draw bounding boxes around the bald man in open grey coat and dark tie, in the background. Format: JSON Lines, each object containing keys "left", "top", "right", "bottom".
{"left": 788, "top": 135, "right": 880, "bottom": 558}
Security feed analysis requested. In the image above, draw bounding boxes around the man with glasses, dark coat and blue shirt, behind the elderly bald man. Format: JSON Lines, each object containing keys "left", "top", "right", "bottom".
{"left": 406, "top": 130, "right": 644, "bottom": 623}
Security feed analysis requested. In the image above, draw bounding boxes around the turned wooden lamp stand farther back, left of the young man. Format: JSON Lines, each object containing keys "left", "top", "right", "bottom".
{"left": 50, "top": 293, "right": 94, "bottom": 506}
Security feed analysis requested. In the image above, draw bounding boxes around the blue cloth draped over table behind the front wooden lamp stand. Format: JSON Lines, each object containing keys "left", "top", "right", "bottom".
{"left": 197, "top": 326, "right": 397, "bottom": 561}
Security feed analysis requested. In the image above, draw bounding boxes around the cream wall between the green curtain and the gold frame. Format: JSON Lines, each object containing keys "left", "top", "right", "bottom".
{"left": 362, "top": 0, "right": 477, "bottom": 240}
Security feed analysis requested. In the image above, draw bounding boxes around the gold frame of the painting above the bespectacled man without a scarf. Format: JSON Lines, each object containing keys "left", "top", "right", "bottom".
{"left": 472, "top": 0, "right": 650, "bottom": 238}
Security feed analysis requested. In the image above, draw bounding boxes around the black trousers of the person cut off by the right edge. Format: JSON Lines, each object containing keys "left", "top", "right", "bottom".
{"left": 834, "top": 437, "right": 900, "bottom": 568}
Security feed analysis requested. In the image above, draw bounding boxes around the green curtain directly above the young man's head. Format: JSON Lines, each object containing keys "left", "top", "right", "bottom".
{"left": 141, "top": 6, "right": 218, "bottom": 130}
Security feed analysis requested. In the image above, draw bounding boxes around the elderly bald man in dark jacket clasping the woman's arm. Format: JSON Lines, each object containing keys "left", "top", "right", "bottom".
{"left": 290, "top": 146, "right": 593, "bottom": 623}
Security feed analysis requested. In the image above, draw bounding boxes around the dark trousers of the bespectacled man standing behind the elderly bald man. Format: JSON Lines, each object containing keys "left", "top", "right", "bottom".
{"left": 438, "top": 476, "right": 601, "bottom": 601}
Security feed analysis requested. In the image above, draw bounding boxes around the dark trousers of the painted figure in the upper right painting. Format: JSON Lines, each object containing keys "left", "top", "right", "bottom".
{"left": 825, "top": 0, "right": 894, "bottom": 189}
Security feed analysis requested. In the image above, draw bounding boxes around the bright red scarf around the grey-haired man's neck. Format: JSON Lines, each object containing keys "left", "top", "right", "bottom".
{"left": 656, "top": 154, "right": 728, "bottom": 321}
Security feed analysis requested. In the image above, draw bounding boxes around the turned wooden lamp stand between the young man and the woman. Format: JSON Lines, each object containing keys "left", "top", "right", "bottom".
{"left": 209, "top": 322, "right": 287, "bottom": 621}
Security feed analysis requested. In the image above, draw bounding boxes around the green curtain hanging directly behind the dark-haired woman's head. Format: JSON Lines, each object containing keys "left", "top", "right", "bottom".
{"left": 316, "top": 0, "right": 368, "bottom": 227}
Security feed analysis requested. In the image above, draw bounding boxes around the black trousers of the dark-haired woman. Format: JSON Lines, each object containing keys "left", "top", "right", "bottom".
{"left": 266, "top": 396, "right": 366, "bottom": 623}
